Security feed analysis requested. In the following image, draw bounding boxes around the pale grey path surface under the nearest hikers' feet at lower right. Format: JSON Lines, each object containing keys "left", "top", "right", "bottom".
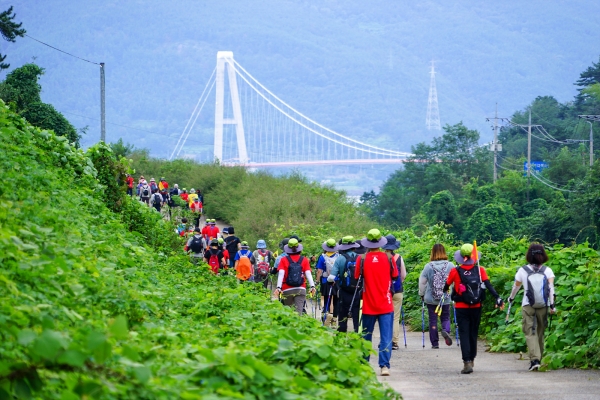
{"left": 371, "top": 327, "right": 600, "bottom": 400}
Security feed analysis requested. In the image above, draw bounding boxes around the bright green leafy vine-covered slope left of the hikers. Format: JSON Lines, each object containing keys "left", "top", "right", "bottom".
{"left": 0, "top": 102, "right": 397, "bottom": 399}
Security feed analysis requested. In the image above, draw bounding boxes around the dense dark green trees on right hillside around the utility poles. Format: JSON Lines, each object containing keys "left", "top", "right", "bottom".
{"left": 368, "top": 58, "right": 600, "bottom": 247}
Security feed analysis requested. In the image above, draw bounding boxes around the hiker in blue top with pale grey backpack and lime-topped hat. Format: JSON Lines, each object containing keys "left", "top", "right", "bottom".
{"left": 317, "top": 239, "right": 339, "bottom": 329}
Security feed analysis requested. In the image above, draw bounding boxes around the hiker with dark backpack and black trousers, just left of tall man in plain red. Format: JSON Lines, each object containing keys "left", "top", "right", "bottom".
{"left": 327, "top": 236, "right": 362, "bottom": 333}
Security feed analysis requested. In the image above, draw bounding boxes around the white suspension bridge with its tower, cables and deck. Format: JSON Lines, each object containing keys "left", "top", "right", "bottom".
{"left": 170, "top": 51, "right": 411, "bottom": 168}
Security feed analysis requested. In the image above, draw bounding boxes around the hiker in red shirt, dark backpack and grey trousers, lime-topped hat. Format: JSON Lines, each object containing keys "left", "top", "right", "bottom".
{"left": 274, "top": 238, "right": 316, "bottom": 315}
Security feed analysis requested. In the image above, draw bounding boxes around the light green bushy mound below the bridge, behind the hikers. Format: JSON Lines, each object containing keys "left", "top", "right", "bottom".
{"left": 131, "top": 151, "right": 370, "bottom": 246}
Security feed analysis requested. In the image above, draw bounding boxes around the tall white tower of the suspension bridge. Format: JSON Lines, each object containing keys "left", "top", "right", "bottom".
{"left": 214, "top": 51, "right": 248, "bottom": 165}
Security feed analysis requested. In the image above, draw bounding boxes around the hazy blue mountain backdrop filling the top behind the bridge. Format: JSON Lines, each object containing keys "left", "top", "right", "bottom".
{"left": 1, "top": 0, "right": 600, "bottom": 179}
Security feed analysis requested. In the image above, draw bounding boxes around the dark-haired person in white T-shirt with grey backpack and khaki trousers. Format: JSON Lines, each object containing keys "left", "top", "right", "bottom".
{"left": 508, "top": 243, "right": 556, "bottom": 371}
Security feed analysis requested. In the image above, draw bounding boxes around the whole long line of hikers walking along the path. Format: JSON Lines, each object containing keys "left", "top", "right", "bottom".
{"left": 127, "top": 176, "right": 556, "bottom": 376}
